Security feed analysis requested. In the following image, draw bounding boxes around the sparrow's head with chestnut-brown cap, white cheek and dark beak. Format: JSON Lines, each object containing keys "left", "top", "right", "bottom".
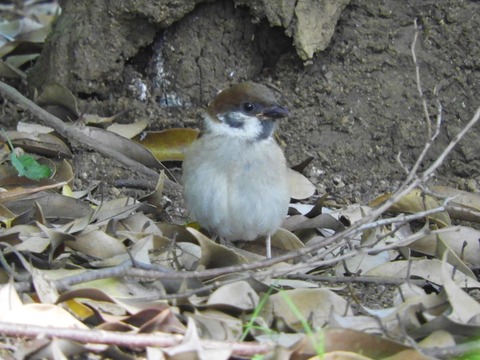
{"left": 204, "top": 82, "right": 289, "bottom": 140}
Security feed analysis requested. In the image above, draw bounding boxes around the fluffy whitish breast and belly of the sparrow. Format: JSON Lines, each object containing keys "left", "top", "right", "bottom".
{"left": 182, "top": 134, "right": 290, "bottom": 240}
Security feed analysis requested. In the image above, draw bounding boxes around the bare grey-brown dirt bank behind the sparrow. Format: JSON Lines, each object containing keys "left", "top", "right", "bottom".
{"left": 3, "top": 0, "right": 480, "bottom": 318}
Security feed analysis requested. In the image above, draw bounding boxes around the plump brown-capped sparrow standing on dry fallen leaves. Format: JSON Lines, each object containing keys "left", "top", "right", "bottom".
{"left": 182, "top": 82, "right": 290, "bottom": 258}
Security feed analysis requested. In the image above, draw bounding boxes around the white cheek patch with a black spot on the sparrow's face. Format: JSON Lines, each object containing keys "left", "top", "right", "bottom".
{"left": 205, "top": 111, "right": 263, "bottom": 139}
